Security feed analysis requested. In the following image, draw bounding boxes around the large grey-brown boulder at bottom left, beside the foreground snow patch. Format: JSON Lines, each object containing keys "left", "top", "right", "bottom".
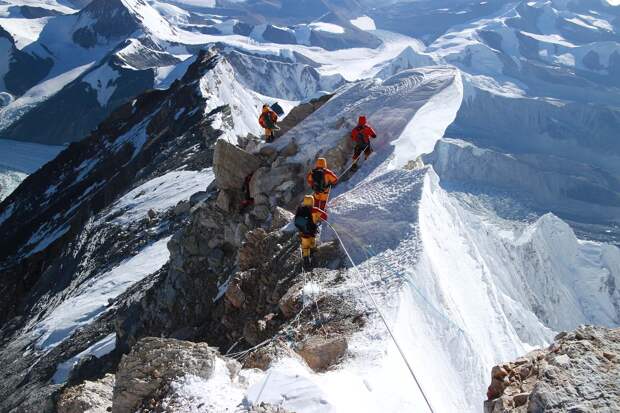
{"left": 112, "top": 337, "right": 217, "bottom": 413}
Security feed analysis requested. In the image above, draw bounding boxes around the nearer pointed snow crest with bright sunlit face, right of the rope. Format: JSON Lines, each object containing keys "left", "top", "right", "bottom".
{"left": 318, "top": 156, "right": 620, "bottom": 412}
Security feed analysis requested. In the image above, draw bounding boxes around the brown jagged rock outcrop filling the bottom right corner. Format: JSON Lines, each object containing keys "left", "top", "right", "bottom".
{"left": 484, "top": 326, "right": 620, "bottom": 413}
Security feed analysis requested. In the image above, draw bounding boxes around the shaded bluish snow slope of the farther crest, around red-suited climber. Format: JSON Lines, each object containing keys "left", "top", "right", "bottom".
{"left": 274, "top": 67, "right": 460, "bottom": 175}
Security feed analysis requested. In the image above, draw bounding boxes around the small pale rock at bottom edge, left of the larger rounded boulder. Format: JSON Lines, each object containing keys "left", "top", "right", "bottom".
{"left": 56, "top": 374, "right": 114, "bottom": 413}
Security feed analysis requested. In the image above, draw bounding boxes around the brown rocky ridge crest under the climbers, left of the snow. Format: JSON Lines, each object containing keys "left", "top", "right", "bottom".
{"left": 48, "top": 62, "right": 365, "bottom": 412}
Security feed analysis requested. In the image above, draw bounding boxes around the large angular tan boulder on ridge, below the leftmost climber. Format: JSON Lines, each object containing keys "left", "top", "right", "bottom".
{"left": 213, "top": 139, "right": 261, "bottom": 190}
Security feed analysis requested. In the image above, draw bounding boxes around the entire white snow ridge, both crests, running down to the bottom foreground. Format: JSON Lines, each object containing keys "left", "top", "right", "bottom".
{"left": 162, "top": 67, "right": 620, "bottom": 413}
